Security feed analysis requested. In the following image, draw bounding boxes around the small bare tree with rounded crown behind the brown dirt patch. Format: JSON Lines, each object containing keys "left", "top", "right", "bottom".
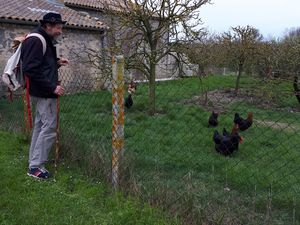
{"left": 220, "top": 26, "right": 262, "bottom": 94}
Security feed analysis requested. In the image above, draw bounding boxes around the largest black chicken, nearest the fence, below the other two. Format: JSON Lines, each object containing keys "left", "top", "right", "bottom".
{"left": 213, "top": 125, "right": 243, "bottom": 156}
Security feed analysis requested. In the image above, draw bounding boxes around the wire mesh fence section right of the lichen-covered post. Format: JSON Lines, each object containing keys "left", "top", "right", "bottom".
{"left": 120, "top": 76, "right": 299, "bottom": 224}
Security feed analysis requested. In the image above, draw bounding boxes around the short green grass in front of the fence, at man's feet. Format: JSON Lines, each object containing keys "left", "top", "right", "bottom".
{"left": 0, "top": 132, "right": 174, "bottom": 225}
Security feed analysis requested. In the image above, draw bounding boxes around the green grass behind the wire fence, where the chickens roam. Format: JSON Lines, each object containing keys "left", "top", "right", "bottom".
{"left": 0, "top": 76, "right": 300, "bottom": 224}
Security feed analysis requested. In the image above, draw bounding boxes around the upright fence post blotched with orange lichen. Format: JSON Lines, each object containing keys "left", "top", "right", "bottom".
{"left": 112, "top": 56, "right": 124, "bottom": 188}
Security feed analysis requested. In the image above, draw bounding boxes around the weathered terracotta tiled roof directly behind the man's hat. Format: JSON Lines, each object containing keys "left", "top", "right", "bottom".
{"left": 0, "top": 0, "right": 106, "bottom": 29}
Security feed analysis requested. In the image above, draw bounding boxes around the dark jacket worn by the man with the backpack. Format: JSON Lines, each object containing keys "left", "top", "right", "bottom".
{"left": 21, "top": 27, "right": 58, "bottom": 98}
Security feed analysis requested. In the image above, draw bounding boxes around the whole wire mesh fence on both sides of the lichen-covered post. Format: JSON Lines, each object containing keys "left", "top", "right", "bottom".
{"left": 0, "top": 57, "right": 300, "bottom": 224}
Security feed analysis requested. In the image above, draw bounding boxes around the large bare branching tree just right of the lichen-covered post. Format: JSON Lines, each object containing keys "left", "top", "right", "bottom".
{"left": 102, "top": 0, "right": 210, "bottom": 115}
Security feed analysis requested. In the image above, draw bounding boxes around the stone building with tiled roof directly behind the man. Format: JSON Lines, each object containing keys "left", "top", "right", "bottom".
{"left": 0, "top": 0, "right": 106, "bottom": 93}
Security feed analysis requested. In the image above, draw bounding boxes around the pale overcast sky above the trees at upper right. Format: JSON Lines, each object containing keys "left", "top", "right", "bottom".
{"left": 200, "top": 0, "right": 300, "bottom": 38}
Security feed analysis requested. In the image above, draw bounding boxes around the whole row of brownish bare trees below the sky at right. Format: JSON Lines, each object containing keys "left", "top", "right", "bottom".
{"left": 180, "top": 26, "right": 300, "bottom": 103}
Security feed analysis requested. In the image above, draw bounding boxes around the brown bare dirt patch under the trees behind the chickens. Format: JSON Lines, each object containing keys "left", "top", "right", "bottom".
{"left": 181, "top": 89, "right": 300, "bottom": 113}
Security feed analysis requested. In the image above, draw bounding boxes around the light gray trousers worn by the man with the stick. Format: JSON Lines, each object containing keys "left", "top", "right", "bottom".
{"left": 29, "top": 97, "right": 57, "bottom": 168}
